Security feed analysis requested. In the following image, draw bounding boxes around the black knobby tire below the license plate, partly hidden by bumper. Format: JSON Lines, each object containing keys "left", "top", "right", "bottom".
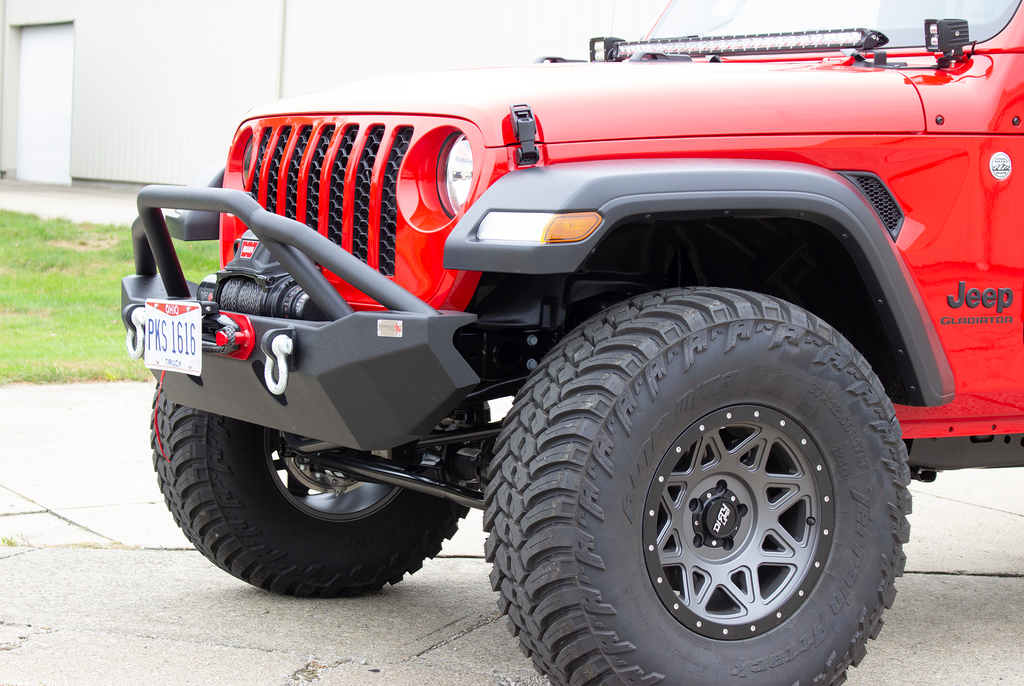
{"left": 151, "top": 385, "right": 468, "bottom": 598}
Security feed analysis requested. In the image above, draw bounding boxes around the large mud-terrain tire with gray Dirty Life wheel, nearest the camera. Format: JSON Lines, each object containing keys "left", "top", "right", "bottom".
{"left": 484, "top": 289, "right": 910, "bottom": 686}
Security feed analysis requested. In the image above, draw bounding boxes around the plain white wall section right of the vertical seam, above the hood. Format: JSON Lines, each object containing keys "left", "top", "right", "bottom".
{"left": 283, "top": 0, "right": 668, "bottom": 96}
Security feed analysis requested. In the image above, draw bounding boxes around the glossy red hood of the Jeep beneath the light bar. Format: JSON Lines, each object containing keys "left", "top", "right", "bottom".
{"left": 250, "top": 62, "right": 925, "bottom": 146}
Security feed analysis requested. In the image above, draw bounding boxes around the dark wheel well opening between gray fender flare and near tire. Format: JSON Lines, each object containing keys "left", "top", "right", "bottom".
{"left": 585, "top": 212, "right": 910, "bottom": 403}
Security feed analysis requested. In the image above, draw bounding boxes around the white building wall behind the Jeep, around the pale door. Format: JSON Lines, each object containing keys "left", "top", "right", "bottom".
{"left": 0, "top": 0, "right": 667, "bottom": 183}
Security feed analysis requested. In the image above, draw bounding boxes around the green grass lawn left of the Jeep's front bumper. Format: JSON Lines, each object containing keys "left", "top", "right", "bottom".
{"left": 0, "top": 211, "right": 218, "bottom": 384}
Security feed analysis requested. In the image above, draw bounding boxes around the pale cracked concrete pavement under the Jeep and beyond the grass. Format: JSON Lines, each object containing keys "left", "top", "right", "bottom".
{"left": 0, "top": 180, "right": 1024, "bottom": 686}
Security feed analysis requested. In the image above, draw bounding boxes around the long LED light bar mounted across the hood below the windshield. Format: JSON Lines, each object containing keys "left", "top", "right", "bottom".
{"left": 608, "top": 29, "right": 889, "bottom": 61}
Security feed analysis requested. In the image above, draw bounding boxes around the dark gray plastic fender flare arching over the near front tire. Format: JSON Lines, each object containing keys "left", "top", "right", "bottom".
{"left": 444, "top": 159, "right": 954, "bottom": 406}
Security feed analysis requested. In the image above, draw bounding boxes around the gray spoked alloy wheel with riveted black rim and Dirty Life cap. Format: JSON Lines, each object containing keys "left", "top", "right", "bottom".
{"left": 643, "top": 405, "right": 834, "bottom": 640}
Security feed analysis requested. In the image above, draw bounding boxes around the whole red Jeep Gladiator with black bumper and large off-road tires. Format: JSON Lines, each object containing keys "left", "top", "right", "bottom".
{"left": 122, "top": 0, "right": 1024, "bottom": 686}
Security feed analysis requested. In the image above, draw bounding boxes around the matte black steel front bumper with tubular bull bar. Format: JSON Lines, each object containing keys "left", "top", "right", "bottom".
{"left": 121, "top": 186, "right": 480, "bottom": 451}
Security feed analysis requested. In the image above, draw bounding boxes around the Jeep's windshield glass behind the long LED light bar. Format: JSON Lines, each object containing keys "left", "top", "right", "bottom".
{"left": 649, "top": 0, "right": 1020, "bottom": 48}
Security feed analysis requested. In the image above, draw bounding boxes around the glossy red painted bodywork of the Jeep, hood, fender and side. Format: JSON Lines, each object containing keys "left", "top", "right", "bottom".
{"left": 224, "top": 21, "right": 1024, "bottom": 438}
